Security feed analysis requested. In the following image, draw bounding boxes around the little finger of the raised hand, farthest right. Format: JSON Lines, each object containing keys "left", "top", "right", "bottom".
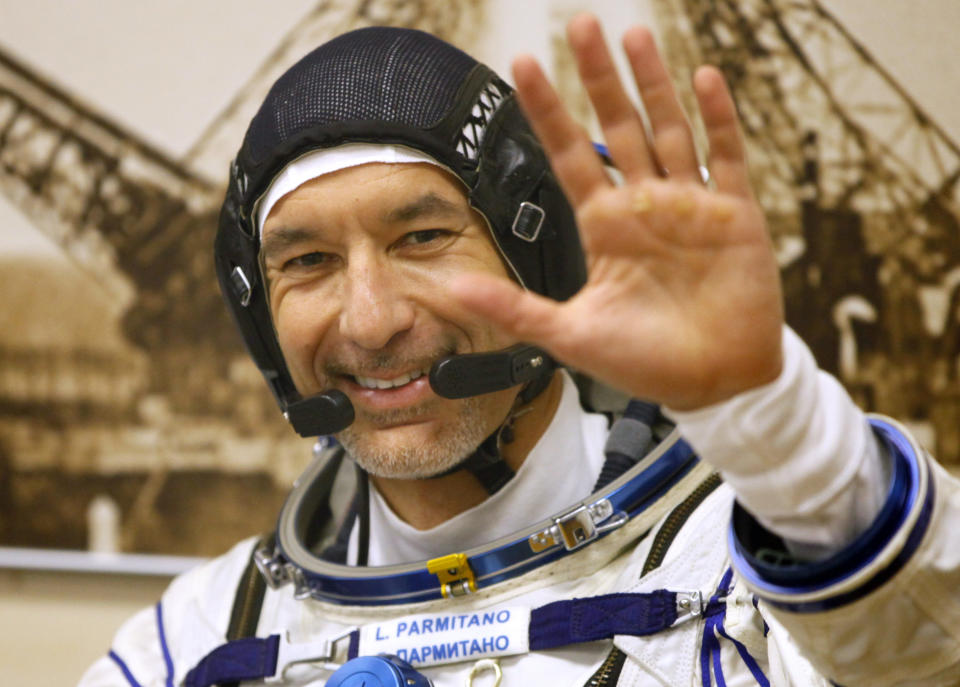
{"left": 693, "top": 67, "right": 753, "bottom": 197}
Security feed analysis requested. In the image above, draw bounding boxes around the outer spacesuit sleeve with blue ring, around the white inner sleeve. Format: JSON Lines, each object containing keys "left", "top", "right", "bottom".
{"left": 730, "top": 418, "right": 960, "bottom": 686}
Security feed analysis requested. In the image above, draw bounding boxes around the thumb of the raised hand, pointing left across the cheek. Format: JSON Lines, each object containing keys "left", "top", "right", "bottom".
{"left": 450, "top": 273, "right": 563, "bottom": 350}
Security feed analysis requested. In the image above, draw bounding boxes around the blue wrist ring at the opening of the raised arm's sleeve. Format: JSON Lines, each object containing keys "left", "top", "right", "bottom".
{"left": 729, "top": 419, "right": 935, "bottom": 613}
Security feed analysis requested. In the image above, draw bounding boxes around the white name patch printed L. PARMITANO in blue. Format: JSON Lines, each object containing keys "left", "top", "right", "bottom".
{"left": 359, "top": 608, "right": 530, "bottom": 666}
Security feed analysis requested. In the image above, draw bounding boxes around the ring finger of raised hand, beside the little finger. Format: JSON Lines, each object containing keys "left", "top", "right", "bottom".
{"left": 623, "top": 27, "right": 700, "bottom": 181}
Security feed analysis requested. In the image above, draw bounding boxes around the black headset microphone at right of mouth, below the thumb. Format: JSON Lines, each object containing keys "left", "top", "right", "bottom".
{"left": 430, "top": 344, "right": 557, "bottom": 398}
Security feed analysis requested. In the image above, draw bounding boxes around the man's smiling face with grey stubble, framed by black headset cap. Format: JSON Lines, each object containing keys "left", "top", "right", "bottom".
{"left": 261, "top": 163, "right": 518, "bottom": 479}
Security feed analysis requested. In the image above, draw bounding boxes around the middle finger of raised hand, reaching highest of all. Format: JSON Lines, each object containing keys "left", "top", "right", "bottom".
{"left": 567, "top": 14, "right": 657, "bottom": 180}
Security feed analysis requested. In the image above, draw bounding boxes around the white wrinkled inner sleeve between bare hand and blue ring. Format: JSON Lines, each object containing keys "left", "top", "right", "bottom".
{"left": 667, "top": 328, "right": 890, "bottom": 560}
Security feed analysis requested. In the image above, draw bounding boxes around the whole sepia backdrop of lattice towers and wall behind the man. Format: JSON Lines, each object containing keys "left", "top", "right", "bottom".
{"left": 0, "top": 0, "right": 960, "bottom": 684}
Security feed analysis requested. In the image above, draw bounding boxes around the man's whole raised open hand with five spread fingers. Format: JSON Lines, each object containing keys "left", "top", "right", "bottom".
{"left": 453, "top": 15, "right": 783, "bottom": 410}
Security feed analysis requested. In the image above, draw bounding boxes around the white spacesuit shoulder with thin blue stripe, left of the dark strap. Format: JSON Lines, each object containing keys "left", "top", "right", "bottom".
{"left": 79, "top": 539, "right": 256, "bottom": 687}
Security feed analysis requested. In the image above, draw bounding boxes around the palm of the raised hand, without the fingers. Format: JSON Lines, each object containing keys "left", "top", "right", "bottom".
{"left": 564, "top": 181, "right": 783, "bottom": 409}
